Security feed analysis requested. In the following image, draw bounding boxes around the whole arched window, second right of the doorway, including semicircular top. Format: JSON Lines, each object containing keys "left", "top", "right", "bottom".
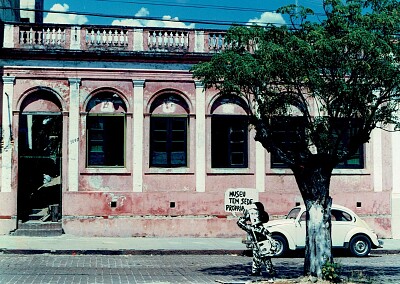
{"left": 150, "top": 94, "right": 189, "bottom": 168}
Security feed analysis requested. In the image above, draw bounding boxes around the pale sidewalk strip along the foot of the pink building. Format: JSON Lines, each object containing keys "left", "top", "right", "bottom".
{"left": 0, "top": 234, "right": 400, "bottom": 254}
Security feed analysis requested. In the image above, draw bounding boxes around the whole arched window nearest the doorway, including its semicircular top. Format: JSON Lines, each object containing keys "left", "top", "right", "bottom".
{"left": 86, "top": 92, "right": 126, "bottom": 167}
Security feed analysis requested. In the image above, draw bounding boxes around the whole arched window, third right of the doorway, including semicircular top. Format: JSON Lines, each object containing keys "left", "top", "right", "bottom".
{"left": 211, "top": 96, "right": 249, "bottom": 168}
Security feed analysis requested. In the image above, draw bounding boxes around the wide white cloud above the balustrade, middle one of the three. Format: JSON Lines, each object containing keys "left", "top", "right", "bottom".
{"left": 111, "top": 7, "right": 195, "bottom": 29}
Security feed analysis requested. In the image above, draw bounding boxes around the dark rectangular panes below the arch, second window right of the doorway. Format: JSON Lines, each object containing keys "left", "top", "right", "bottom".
{"left": 150, "top": 116, "right": 188, "bottom": 168}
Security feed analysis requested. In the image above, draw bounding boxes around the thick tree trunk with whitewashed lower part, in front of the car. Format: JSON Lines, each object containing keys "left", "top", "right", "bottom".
{"left": 294, "top": 166, "right": 333, "bottom": 278}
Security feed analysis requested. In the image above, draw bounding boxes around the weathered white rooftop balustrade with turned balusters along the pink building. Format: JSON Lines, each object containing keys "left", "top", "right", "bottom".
{"left": 3, "top": 23, "right": 230, "bottom": 53}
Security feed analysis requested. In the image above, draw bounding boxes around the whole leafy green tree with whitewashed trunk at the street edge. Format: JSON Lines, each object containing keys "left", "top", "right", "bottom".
{"left": 192, "top": 0, "right": 400, "bottom": 278}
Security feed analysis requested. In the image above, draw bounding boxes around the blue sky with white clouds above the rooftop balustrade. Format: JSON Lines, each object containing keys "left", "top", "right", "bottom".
{"left": 44, "top": 0, "right": 322, "bottom": 29}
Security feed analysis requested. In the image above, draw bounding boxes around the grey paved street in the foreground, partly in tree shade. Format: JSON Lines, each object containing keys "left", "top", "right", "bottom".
{"left": 0, "top": 254, "right": 400, "bottom": 284}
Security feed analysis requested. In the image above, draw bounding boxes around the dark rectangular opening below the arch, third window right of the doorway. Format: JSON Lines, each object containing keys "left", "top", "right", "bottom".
{"left": 211, "top": 115, "right": 248, "bottom": 168}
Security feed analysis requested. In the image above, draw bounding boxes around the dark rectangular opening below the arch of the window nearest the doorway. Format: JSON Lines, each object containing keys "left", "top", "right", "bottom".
{"left": 86, "top": 114, "right": 125, "bottom": 167}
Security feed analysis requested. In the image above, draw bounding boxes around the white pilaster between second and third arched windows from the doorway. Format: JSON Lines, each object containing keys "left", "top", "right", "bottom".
{"left": 195, "top": 81, "right": 206, "bottom": 192}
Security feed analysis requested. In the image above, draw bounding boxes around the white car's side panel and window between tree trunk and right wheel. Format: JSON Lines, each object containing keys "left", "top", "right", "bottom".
{"left": 331, "top": 209, "right": 354, "bottom": 247}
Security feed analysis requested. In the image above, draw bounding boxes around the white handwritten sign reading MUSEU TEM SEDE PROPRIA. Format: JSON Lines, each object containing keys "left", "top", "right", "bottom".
{"left": 224, "top": 188, "right": 258, "bottom": 212}
